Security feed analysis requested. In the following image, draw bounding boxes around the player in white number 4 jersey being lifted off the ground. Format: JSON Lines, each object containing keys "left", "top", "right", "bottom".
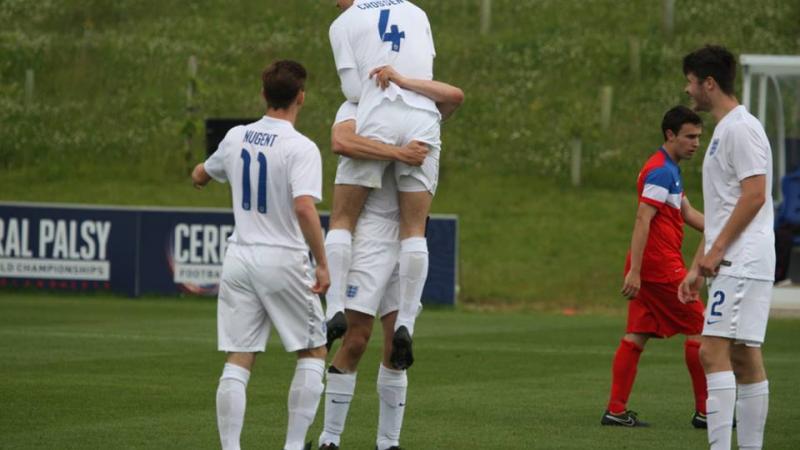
{"left": 325, "top": 0, "right": 450, "bottom": 368}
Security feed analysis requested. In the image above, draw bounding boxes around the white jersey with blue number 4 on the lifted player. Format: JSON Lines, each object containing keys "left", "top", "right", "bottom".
{"left": 329, "top": 0, "right": 439, "bottom": 118}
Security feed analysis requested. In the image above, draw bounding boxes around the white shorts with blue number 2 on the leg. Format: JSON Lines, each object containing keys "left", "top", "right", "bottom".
{"left": 703, "top": 275, "right": 772, "bottom": 347}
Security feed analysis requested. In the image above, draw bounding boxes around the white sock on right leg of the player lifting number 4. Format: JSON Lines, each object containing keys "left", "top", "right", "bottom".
{"left": 376, "top": 364, "right": 408, "bottom": 450}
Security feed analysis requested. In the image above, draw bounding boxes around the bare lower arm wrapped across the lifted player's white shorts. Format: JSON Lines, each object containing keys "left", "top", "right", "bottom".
{"left": 331, "top": 120, "right": 428, "bottom": 166}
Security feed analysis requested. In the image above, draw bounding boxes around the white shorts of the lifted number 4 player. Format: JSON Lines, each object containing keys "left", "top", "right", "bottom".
{"left": 335, "top": 99, "right": 442, "bottom": 195}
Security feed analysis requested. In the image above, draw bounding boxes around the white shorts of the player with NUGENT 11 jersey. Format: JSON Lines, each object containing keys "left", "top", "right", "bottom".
{"left": 217, "top": 244, "right": 326, "bottom": 353}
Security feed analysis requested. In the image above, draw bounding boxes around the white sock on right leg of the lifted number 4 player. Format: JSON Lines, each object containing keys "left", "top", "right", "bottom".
{"left": 394, "top": 237, "right": 428, "bottom": 336}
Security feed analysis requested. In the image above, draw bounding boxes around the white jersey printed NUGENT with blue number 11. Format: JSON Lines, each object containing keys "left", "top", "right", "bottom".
{"left": 204, "top": 116, "right": 322, "bottom": 251}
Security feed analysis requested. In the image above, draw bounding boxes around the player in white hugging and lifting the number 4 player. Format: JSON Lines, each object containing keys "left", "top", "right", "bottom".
{"left": 319, "top": 67, "right": 464, "bottom": 450}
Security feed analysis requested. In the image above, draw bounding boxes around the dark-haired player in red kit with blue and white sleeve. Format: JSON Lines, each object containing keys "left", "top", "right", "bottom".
{"left": 600, "top": 106, "right": 707, "bottom": 428}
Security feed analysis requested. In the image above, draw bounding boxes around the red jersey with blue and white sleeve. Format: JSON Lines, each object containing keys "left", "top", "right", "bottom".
{"left": 625, "top": 147, "right": 686, "bottom": 283}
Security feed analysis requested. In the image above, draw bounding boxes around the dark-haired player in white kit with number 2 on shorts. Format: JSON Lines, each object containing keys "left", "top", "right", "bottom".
{"left": 680, "top": 46, "right": 775, "bottom": 450}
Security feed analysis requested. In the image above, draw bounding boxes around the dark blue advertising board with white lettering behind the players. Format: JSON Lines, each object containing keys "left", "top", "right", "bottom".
{"left": 0, "top": 202, "right": 458, "bottom": 305}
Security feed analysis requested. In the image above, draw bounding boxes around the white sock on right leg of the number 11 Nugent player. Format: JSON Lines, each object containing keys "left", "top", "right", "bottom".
{"left": 284, "top": 358, "right": 325, "bottom": 450}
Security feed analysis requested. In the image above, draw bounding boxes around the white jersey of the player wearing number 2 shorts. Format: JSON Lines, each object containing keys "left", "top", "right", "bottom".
{"left": 703, "top": 105, "right": 775, "bottom": 280}
